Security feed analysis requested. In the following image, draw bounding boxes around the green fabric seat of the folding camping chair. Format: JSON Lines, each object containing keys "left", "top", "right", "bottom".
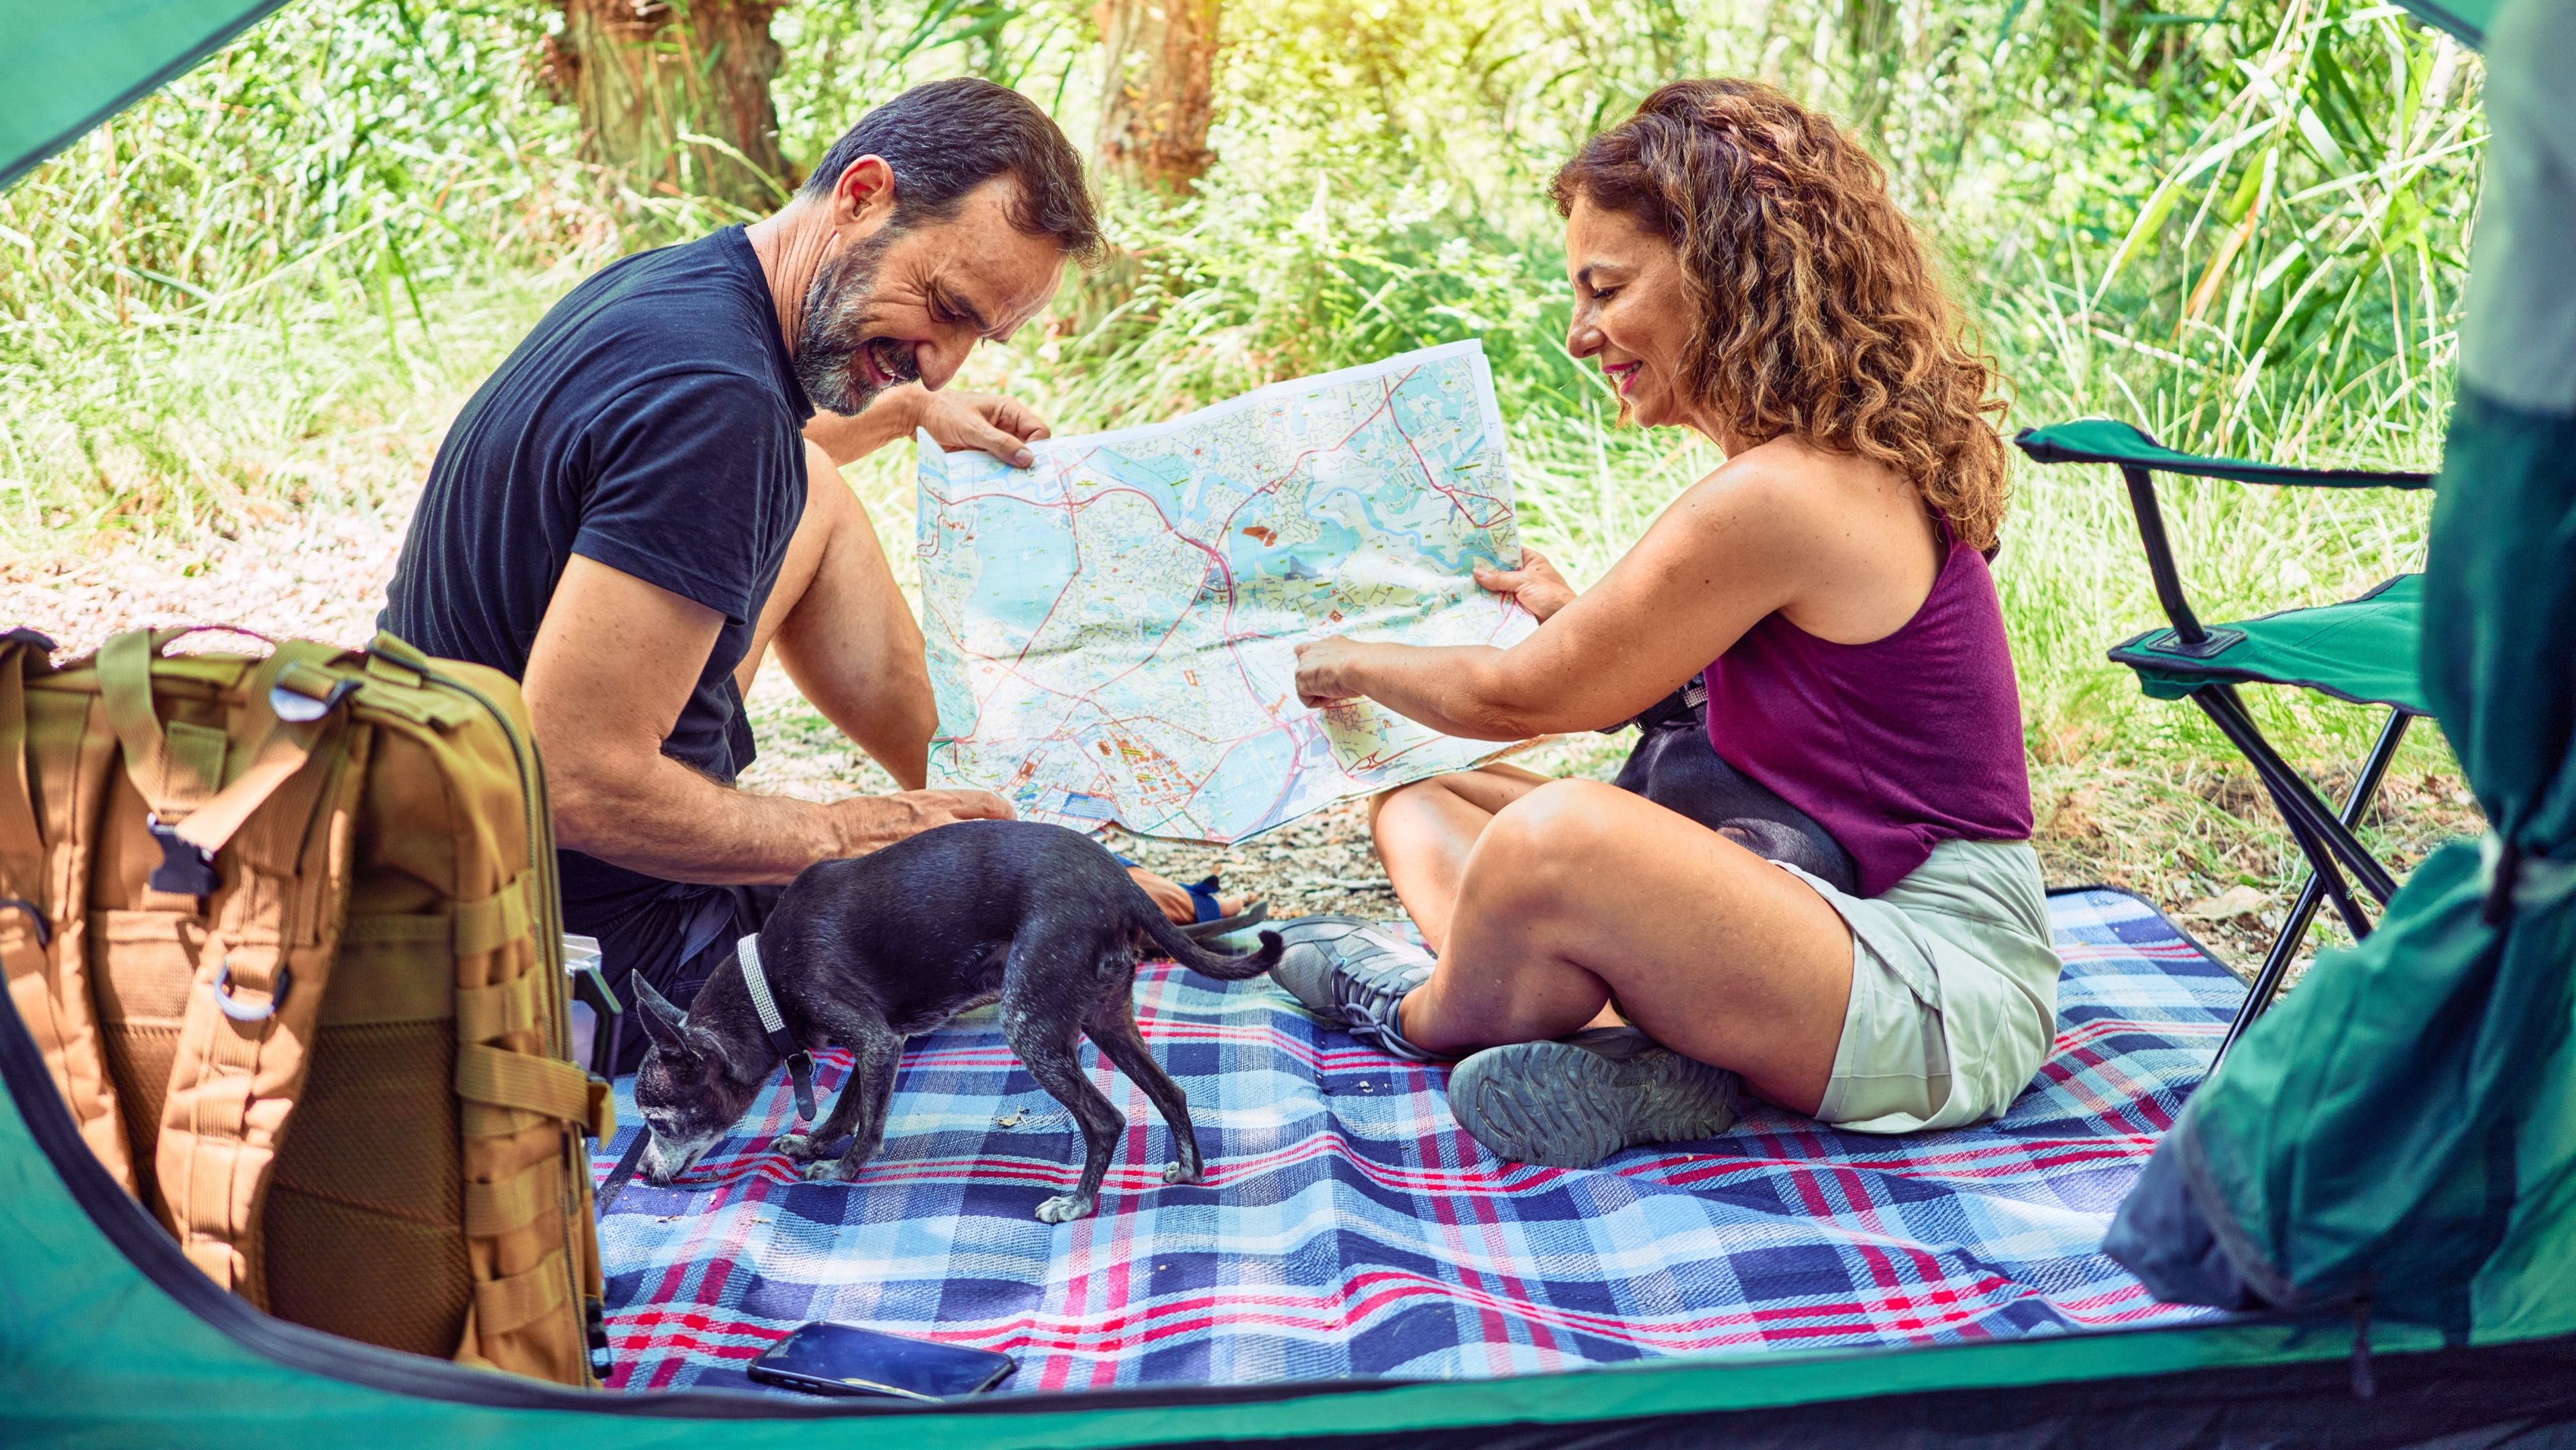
{"left": 2110, "top": 574, "right": 2432, "bottom": 713}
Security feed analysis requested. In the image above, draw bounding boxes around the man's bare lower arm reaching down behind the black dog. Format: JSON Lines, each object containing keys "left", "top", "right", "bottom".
{"left": 523, "top": 554, "right": 1010, "bottom": 886}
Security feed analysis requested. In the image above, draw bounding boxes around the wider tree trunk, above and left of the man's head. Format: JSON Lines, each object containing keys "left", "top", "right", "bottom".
{"left": 549, "top": 0, "right": 788, "bottom": 211}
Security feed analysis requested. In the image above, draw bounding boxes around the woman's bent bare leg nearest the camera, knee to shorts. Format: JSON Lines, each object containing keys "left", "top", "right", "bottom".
{"left": 1401, "top": 780, "right": 1852, "bottom": 1112}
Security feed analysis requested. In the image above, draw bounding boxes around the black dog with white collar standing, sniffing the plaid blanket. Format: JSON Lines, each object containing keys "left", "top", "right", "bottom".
{"left": 631, "top": 821, "right": 1280, "bottom": 1223}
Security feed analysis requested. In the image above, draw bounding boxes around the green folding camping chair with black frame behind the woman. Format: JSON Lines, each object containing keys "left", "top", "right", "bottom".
{"left": 2017, "top": 417, "right": 2432, "bottom": 1066}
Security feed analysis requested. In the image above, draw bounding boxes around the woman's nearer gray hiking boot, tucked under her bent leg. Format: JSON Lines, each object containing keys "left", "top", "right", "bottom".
{"left": 1450, "top": 1028, "right": 1744, "bottom": 1170}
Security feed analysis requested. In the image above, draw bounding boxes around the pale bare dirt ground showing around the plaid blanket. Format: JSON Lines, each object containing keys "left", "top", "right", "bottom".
{"left": 0, "top": 507, "right": 2481, "bottom": 974}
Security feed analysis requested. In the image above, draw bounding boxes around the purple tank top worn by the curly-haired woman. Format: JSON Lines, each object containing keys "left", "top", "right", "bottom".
{"left": 1708, "top": 528, "right": 2030, "bottom": 896}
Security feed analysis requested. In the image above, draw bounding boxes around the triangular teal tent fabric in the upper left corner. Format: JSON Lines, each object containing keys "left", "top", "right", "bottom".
{"left": 0, "top": 0, "right": 283, "bottom": 188}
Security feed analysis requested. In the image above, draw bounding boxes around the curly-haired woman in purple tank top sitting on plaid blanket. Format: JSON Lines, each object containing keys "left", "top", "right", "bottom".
{"left": 1278, "top": 80, "right": 2058, "bottom": 1167}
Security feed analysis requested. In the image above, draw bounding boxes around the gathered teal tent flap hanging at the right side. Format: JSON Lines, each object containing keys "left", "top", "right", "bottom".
{"left": 2107, "top": 0, "right": 2576, "bottom": 1342}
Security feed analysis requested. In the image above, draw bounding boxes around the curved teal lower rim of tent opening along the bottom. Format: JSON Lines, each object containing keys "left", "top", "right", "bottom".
{"left": 0, "top": 942, "right": 2514, "bottom": 1447}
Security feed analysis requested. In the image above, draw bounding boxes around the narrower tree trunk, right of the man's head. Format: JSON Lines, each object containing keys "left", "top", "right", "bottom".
{"left": 1097, "top": 0, "right": 1218, "bottom": 196}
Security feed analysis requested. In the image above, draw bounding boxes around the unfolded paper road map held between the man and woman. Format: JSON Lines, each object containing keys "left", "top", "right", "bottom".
{"left": 920, "top": 343, "right": 1536, "bottom": 842}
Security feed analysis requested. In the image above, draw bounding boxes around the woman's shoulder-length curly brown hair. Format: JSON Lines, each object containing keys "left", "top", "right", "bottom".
{"left": 1548, "top": 80, "right": 2009, "bottom": 549}
